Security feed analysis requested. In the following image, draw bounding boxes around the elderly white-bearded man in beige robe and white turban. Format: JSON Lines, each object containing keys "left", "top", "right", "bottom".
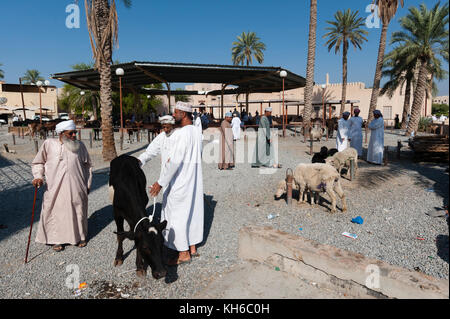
{"left": 31, "top": 120, "right": 92, "bottom": 251}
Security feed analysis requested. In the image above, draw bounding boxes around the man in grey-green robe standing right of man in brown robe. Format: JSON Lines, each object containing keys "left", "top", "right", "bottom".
{"left": 252, "top": 107, "right": 281, "bottom": 168}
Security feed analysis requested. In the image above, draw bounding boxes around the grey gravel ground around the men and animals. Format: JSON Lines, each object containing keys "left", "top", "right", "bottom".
{"left": 0, "top": 127, "right": 449, "bottom": 298}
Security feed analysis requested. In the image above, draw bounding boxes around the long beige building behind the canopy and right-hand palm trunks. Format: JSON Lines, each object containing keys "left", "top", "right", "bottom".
{"left": 185, "top": 75, "right": 431, "bottom": 120}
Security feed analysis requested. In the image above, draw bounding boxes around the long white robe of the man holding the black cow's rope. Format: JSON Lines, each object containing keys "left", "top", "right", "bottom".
{"left": 158, "top": 125, "right": 204, "bottom": 251}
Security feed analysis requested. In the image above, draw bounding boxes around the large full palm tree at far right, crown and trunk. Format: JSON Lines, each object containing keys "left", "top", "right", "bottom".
{"left": 391, "top": 2, "right": 449, "bottom": 135}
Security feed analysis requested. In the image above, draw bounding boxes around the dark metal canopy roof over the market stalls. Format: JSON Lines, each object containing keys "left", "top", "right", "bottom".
{"left": 52, "top": 61, "right": 306, "bottom": 95}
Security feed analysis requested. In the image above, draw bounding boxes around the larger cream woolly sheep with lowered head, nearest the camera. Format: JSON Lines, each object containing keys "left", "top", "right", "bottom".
{"left": 275, "top": 163, "right": 347, "bottom": 213}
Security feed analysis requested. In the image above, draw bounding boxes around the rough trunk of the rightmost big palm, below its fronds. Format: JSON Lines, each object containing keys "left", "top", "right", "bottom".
{"left": 406, "top": 60, "right": 428, "bottom": 136}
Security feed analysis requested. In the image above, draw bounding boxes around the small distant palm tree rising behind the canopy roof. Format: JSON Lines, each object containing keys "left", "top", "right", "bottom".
{"left": 231, "top": 31, "right": 266, "bottom": 110}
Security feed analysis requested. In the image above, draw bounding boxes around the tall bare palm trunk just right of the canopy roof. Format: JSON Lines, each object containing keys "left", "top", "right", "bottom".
{"left": 303, "top": 0, "right": 317, "bottom": 130}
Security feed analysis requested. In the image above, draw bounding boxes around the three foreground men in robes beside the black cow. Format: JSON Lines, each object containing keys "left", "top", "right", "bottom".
{"left": 32, "top": 102, "right": 204, "bottom": 265}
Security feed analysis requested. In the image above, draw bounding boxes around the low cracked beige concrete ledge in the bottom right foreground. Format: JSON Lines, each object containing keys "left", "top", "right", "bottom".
{"left": 239, "top": 226, "right": 449, "bottom": 299}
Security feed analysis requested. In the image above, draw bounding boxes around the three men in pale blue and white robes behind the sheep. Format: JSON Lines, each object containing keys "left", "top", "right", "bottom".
{"left": 336, "top": 108, "right": 384, "bottom": 164}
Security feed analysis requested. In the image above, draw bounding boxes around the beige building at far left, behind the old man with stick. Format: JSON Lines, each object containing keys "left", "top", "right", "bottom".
{"left": 0, "top": 81, "right": 58, "bottom": 119}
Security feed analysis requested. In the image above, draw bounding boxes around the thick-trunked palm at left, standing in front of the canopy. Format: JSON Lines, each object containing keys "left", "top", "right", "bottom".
{"left": 85, "top": 0, "right": 131, "bottom": 161}
